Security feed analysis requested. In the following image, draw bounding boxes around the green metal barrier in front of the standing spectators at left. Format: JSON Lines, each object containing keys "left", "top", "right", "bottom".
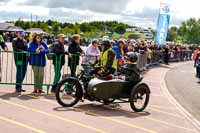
{"left": 0, "top": 51, "right": 81, "bottom": 92}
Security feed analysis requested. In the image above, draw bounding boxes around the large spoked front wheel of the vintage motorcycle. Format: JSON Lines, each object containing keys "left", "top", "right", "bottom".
{"left": 56, "top": 78, "right": 82, "bottom": 107}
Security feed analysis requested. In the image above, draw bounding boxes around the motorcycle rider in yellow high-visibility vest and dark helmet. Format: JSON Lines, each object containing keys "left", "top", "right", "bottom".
{"left": 98, "top": 40, "right": 117, "bottom": 78}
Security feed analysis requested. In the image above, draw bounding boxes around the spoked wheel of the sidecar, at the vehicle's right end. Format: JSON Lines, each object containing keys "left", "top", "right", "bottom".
{"left": 130, "top": 84, "right": 150, "bottom": 112}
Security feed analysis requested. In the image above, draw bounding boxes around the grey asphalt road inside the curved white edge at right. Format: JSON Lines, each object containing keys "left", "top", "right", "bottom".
{"left": 166, "top": 62, "right": 200, "bottom": 121}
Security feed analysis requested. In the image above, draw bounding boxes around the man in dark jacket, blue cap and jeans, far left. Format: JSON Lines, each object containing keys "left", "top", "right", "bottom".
{"left": 12, "top": 31, "right": 28, "bottom": 92}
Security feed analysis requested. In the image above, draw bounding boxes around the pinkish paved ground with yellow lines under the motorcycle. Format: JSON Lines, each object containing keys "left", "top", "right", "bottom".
{"left": 0, "top": 44, "right": 198, "bottom": 133}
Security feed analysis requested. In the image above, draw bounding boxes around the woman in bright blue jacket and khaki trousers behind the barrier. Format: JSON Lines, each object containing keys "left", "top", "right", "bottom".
{"left": 28, "top": 34, "right": 49, "bottom": 93}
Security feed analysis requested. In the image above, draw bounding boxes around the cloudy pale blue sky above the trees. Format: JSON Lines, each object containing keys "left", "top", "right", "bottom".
{"left": 0, "top": 0, "right": 200, "bottom": 27}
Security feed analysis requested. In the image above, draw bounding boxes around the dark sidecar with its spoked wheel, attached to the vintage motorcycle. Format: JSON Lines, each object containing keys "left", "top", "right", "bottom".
{"left": 86, "top": 78, "right": 150, "bottom": 112}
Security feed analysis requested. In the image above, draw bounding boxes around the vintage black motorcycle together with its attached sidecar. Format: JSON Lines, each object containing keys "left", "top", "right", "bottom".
{"left": 55, "top": 64, "right": 150, "bottom": 112}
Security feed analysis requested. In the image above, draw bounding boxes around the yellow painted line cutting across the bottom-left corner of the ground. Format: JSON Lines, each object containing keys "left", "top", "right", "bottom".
{"left": 0, "top": 116, "right": 47, "bottom": 133}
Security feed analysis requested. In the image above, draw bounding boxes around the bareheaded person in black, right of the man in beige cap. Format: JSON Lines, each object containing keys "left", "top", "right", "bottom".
{"left": 68, "top": 35, "right": 84, "bottom": 77}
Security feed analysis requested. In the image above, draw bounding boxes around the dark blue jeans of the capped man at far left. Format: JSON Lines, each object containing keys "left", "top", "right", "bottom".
{"left": 16, "top": 64, "right": 27, "bottom": 90}
